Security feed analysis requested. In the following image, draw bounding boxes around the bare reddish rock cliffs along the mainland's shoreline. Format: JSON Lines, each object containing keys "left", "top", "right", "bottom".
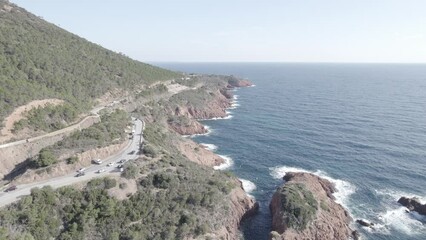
{"left": 168, "top": 77, "right": 259, "bottom": 240}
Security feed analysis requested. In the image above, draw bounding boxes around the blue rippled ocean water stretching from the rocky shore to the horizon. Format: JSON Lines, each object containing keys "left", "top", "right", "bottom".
{"left": 159, "top": 63, "right": 426, "bottom": 240}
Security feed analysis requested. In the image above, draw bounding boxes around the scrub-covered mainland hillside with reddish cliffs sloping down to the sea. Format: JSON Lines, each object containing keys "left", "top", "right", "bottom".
{"left": 0, "top": 0, "right": 257, "bottom": 240}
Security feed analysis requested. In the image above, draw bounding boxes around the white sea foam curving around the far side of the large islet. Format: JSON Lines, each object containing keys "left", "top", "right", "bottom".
{"left": 270, "top": 166, "right": 356, "bottom": 209}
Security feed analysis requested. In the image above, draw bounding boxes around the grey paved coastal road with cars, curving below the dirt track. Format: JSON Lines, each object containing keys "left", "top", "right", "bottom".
{"left": 0, "top": 119, "right": 145, "bottom": 207}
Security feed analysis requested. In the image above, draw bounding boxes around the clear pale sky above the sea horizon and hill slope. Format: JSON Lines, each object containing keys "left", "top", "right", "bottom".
{"left": 11, "top": 0, "right": 426, "bottom": 63}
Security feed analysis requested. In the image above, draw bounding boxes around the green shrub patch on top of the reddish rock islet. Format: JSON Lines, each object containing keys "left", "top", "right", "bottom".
{"left": 278, "top": 183, "right": 318, "bottom": 230}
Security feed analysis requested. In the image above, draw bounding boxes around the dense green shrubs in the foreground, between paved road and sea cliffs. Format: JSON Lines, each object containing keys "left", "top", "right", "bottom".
{"left": 0, "top": 134, "right": 234, "bottom": 240}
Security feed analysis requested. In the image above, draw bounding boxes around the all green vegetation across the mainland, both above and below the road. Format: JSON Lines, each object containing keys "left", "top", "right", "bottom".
{"left": 0, "top": 0, "right": 250, "bottom": 240}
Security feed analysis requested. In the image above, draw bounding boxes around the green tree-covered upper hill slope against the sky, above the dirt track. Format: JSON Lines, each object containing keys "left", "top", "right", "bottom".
{"left": 0, "top": 0, "right": 180, "bottom": 124}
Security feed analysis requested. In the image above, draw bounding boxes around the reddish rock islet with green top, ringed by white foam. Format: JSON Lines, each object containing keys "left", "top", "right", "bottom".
{"left": 270, "top": 173, "right": 355, "bottom": 240}
